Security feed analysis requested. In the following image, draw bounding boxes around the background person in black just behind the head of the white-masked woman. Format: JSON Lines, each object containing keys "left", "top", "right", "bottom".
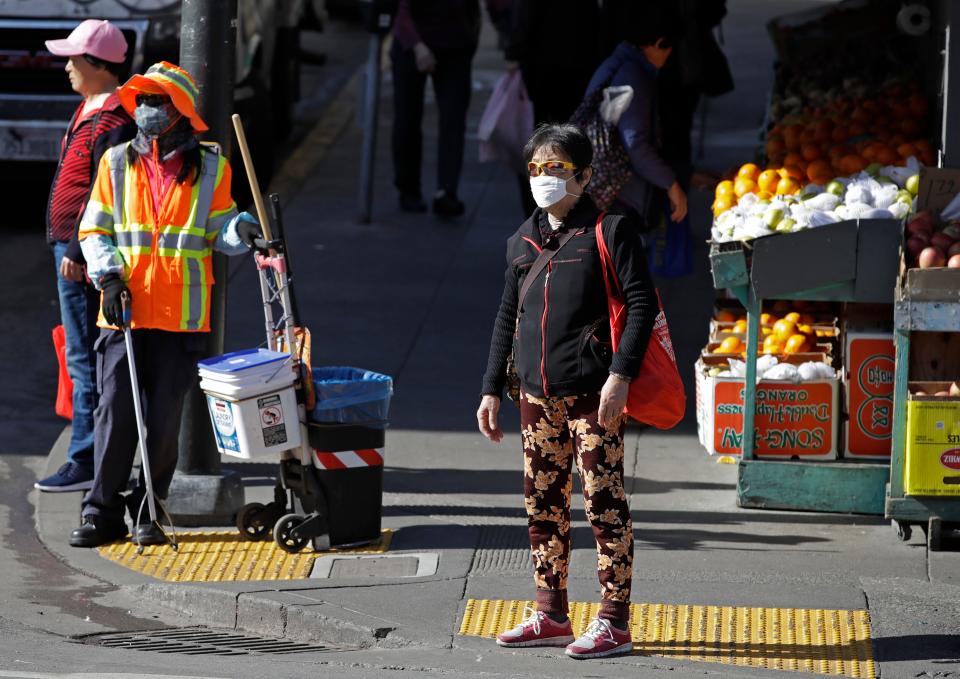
{"left": 504, "top": 0, "right": 605, "bottom": 217}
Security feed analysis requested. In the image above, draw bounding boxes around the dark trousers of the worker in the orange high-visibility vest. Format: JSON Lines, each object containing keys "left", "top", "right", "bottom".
{"left": 81, "top": 329, "right": 207, "bottom": 523}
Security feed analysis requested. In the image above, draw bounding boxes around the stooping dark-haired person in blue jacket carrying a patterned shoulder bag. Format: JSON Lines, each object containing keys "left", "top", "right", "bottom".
{"left": 587, "top": 2, "right": 687, "bottom": 230}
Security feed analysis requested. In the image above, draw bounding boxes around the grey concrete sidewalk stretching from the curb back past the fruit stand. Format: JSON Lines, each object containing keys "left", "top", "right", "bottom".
{"left": 31, "top": 2, "right": 960, "bottom": 677}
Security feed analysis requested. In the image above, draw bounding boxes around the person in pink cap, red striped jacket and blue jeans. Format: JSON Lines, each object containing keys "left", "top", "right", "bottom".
{"left": 34, "top": 19, "right": 137, "bottom": 492}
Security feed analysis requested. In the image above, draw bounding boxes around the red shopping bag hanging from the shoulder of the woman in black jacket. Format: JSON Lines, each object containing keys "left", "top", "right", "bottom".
{"left": 596, "top": 214, "right": 687, "bottom": 429}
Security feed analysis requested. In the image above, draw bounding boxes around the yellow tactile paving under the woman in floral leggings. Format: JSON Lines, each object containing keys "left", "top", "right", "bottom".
{"left": 460, "top": 599, "right": 877, "bottom": 679}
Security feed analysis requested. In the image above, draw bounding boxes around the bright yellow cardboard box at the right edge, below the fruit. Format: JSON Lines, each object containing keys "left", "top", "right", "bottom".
{"left": 903, "top": 382, "right": 960, "bottom": 496}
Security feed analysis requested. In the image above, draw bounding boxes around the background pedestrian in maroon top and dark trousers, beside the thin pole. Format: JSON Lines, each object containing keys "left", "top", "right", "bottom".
{"left": 390, "top": 0, "right": 481, "bottom": 217}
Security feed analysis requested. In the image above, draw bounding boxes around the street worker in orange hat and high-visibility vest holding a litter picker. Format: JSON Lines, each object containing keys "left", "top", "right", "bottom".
{"left": 70, "top": 61, "right": 261, "bottom": 547}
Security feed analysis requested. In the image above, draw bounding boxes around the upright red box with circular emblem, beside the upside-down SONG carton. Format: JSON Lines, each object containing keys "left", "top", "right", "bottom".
{"left": 843, "top": 331, "right": 895, "bottom": 459}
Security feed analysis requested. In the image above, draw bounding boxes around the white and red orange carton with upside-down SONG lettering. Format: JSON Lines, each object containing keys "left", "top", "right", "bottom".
{"left": 695, "top": 354, "right": 840, "bottom": 460}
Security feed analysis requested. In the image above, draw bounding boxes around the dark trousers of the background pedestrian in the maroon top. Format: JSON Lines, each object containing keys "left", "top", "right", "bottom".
{"left": 390, "top": 42, "right": 476, "bottom": 196}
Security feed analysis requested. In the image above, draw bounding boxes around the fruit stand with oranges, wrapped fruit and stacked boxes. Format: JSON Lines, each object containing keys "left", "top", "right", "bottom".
{"left": 696, "top": 0, "right": 960, "bottom": 524}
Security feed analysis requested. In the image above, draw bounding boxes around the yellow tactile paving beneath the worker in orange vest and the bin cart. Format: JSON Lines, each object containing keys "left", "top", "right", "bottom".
{"left": 97, "top": 529, "right": 393, "bottom": 582}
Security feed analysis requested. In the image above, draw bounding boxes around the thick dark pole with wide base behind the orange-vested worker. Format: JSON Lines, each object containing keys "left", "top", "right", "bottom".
{"left": 168, "top": 0, "right": 244, "bottom": 525}
